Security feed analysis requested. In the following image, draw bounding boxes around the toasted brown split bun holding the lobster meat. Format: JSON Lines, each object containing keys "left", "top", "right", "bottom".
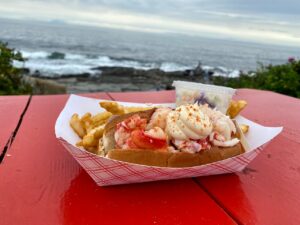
{"left": 103, "top": 109, "right": 245, "bottom": 167}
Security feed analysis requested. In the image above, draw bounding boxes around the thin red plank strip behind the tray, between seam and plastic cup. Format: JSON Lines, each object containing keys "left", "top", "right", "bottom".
{"left": 109, "top": 91, "right": 175, "bottom": 103}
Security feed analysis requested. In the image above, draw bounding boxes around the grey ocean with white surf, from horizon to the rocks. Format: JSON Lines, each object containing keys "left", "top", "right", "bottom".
{"left": 0, "top": 19, "right": 300, "bottom": 76}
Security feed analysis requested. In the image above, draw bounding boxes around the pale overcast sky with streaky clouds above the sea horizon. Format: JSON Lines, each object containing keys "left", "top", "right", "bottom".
{"left": 0, "top": 0, "right": 300, "bottom": 46}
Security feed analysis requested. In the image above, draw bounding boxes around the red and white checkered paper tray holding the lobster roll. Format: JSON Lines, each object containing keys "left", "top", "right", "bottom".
{"left": 55, "top": 95, "right": 282, "bottom": 186}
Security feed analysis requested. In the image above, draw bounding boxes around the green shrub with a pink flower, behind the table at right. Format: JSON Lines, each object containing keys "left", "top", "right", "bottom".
{"left": 213, "top": 59, "right": 300, "bottom": 98}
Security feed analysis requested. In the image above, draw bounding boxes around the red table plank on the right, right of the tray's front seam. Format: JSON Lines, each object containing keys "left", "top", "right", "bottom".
{"left": 198, "top": 90, "right": 300, "bottom": 225}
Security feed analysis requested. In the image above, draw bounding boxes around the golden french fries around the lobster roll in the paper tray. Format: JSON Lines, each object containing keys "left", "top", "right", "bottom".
{"left": 70, "top": 100, "right": 249, "bottom": 155}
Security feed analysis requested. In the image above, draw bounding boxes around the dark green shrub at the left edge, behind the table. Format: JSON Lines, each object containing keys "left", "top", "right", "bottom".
{"left": 0, "top": 42, "right": 32, "bottom": 95}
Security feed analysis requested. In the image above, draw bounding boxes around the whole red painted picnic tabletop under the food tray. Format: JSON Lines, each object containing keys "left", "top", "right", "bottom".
{"left": 0, "top": 89, "right": 300, "bottom": 225}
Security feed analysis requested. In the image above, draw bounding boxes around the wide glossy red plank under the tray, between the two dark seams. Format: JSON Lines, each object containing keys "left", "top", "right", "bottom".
{"left": 0, "top": 92, "right": 236, "bottom": 225}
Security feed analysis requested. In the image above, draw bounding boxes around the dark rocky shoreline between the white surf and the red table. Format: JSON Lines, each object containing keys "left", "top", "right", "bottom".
{"left": 24, "top": 66, "right": 230, "bottom": 94}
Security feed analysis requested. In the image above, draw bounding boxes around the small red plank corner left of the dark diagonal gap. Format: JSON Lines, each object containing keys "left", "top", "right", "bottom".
{"left": 0, "top": 96, "right": 29, "bottom": 156}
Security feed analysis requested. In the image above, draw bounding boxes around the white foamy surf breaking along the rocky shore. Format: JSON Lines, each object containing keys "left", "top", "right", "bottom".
{"left": 16, "top": 51, "right": 239, "bottom": 77}
